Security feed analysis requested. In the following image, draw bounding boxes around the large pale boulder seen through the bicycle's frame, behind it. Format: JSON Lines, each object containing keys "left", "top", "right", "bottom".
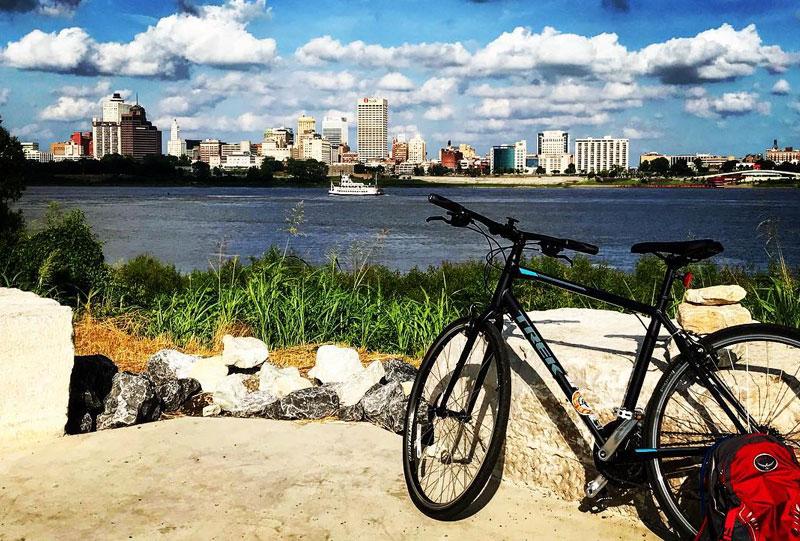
{"left": 500, "top": 308, "right": 669, "bottom": 500}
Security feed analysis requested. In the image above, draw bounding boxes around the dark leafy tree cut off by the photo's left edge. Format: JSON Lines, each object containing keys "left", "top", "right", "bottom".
{"left": 0, "top": 112, "right": 27, "bottom": 264}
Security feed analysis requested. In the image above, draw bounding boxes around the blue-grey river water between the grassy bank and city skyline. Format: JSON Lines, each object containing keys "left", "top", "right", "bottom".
{"left": 14, "top": 186, "right": 800, "bottom": 271}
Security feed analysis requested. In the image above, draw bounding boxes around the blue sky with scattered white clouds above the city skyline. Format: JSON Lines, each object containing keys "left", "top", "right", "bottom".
{"left": 0, "top": 0, "right": 800, "bottom": 158}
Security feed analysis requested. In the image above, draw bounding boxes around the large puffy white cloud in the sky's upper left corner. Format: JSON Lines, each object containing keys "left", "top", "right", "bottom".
{"left": 0, "top": 0, "right": 277, "bottom": 78}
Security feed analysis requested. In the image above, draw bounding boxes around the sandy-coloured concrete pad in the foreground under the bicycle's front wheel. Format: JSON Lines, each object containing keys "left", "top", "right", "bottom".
{"left": 0, "top": 417, "right": 658, "bottom": 541}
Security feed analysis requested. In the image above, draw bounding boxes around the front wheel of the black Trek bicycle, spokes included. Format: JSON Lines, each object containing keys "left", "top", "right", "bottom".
{"left": 403, "top": 318, "right": 511, "bottom": 520}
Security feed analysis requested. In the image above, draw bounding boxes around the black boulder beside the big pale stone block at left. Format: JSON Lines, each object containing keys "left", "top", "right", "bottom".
{"left": 66, "top": 355, "right": 119, "bottom": 434}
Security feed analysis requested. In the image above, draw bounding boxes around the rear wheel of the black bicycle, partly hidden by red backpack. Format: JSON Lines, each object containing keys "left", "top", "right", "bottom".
{"left": 645, "top": 324, "right": 800, "bottom": 536}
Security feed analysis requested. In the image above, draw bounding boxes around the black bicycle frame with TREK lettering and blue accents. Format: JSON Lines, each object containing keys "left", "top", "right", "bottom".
{"left": 439, "top": 243, "right": 748, "bottom": 460}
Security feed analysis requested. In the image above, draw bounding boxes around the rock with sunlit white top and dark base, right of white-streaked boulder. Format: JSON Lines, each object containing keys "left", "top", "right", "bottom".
{"left": 147, "top": 349, "right": 200, "bottom": 412}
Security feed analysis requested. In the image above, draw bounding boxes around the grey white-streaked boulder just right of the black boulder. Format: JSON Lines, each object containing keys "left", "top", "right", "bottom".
{"left": 97, "top": 372, "right": 161, "bottom": 430}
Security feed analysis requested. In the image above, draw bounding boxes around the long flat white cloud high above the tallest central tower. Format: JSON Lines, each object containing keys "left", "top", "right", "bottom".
{"left": 295, "top": 36, "right": 469, "bottom": 69}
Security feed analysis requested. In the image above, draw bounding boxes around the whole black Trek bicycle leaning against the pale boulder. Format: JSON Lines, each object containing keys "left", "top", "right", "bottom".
{"left": 403, "top": 194, "right": 800, "bottom": 536}
